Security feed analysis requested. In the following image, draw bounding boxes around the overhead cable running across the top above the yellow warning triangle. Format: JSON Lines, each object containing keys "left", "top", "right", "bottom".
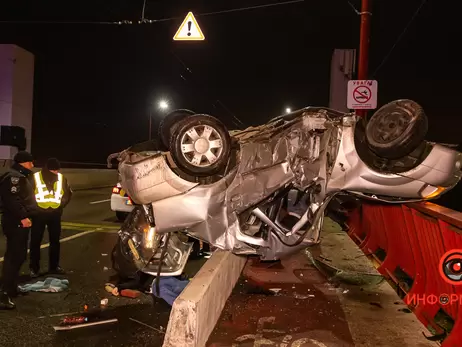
{"left": 0, "top": 0, "right": 305, "bottom": 25}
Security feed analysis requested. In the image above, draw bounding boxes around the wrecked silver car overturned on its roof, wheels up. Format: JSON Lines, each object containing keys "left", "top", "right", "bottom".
{"left": 108, "top": 100, "right": 462, "bottom": 276}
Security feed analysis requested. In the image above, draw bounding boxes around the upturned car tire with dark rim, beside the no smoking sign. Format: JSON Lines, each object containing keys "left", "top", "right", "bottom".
{"left": 366, "top": 99, "right": 428, "bottom": 159}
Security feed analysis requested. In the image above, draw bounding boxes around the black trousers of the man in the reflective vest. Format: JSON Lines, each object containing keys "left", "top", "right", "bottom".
{"left": 29, "top": 212, "right": 61, "bottom": 272}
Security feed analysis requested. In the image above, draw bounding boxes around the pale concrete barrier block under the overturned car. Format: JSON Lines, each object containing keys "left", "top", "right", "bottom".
{"left": 163, "top": 250, "right": 247, "bottom": 347}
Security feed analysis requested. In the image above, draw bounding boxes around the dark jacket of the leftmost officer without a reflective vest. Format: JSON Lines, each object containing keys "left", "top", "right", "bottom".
{"left": 0, "top": 163, "right": 38, "bottom": 226}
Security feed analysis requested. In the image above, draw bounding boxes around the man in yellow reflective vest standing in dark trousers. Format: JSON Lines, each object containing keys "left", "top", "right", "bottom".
{"left": 29, "top": 158, "right": 72, "bottom": 278}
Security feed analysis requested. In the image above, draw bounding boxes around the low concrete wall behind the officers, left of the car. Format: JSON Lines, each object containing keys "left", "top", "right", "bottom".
{"left": 0, "top": 167, "right": 118, "bottom": 190}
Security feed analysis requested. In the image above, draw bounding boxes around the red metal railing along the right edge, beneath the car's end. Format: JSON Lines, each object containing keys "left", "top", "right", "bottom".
{"left": 348, "top": 202, "right": 462, "bottom": 347}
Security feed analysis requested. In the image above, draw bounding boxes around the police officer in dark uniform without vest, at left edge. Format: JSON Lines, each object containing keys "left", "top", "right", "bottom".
{"left": 0, "top": 151, "right": 37, "bottom": 309}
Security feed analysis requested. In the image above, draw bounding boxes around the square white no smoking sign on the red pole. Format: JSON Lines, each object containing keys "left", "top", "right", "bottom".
{"left": 347, "top": 80, "right": 377, "bottom": 110}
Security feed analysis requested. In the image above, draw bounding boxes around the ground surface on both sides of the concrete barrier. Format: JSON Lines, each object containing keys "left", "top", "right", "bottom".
{"left": 0, "top": 188, "right": 435, "bottom": 347}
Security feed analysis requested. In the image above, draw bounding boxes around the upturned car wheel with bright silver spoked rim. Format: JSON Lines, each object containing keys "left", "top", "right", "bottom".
{"left": 170, "top": 114, "right": 231, "bottom": 176}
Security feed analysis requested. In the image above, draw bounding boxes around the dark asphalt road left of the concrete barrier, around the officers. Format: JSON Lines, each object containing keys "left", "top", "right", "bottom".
{"left": 0, "top": 188, "right": 197, "bottom": 347}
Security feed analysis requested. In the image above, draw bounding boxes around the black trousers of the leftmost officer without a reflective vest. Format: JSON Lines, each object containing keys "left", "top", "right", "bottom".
{"left": 2, "top": 223, "right": 30, "bottom": 295}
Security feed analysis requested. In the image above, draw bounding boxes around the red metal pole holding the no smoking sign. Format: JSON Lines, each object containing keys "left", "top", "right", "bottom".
{"left": 356, "top": 0, "right": 372, "bottom": 117}
